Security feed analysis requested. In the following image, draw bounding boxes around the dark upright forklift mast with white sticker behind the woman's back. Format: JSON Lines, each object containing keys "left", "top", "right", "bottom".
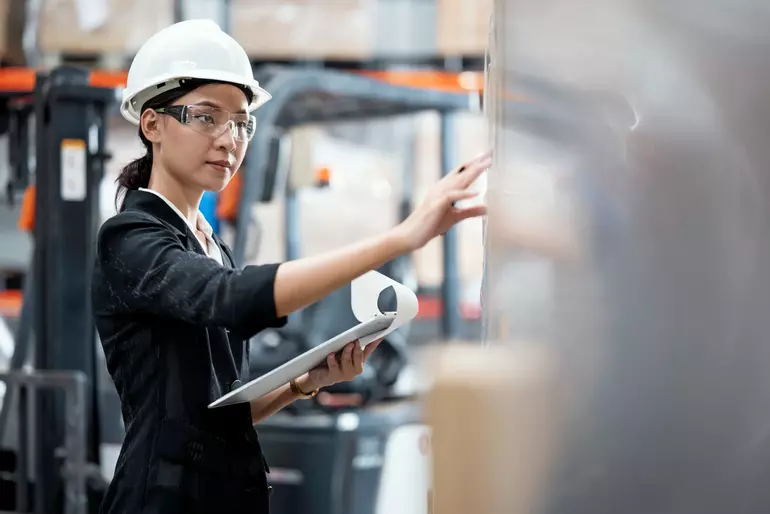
{"left": 0, "top": 67, "right": 115, "bottom": 514}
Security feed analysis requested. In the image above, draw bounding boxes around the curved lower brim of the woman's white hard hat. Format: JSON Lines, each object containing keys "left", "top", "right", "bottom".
{"left": 120, "top": 70, "right": 272, "bottom": 125}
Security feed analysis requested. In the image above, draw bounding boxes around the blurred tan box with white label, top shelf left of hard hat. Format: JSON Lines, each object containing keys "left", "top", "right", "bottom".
{"left": 38, "top": 0, "right": 174, "bottom": 55}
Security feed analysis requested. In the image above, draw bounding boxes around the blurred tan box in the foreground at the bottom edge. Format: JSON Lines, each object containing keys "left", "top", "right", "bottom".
{"left": 426, "top": 343, "right": 560, "bottom": 514}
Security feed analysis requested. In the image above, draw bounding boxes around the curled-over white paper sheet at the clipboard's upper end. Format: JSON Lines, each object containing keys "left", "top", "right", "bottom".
{"left": 350, "top": 271, "right": 419, "bottom": 345}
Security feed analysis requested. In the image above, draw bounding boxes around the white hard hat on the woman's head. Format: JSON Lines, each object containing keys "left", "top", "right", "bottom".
{"left": 120, "top": 20, "right": 271, "bottom": 125}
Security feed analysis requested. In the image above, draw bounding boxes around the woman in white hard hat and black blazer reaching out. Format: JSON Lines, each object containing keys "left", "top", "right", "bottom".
{"left": 92, "top": 21, "right": 489, "bottom": 514}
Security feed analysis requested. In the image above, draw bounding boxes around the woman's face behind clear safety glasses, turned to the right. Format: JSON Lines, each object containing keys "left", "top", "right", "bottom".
{"left": 146, "top": 84, "right": 248, "bottom": 192}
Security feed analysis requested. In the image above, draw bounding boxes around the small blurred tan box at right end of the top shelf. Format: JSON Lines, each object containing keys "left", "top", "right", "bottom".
{"left": 436, "top": 0, "right": 493, "bottom": 56}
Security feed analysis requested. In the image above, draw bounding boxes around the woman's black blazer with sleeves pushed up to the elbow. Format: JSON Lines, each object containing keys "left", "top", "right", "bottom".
{"left": 92, "top": 191, "right": 286, "bottom": 514}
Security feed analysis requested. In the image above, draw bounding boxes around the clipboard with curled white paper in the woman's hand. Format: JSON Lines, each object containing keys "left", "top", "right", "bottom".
{"left": 208, "top": 271, "right": 419, "bottom": 409}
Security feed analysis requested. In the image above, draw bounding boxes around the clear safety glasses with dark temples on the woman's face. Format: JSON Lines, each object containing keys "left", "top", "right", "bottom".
{"left": 155, "top": 105, "right": 257, "bottom": 142}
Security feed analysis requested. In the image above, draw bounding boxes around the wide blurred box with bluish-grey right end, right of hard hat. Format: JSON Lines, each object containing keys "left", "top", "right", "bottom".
{"left": 231, "top": 0, "right": 436, "bottom": 60}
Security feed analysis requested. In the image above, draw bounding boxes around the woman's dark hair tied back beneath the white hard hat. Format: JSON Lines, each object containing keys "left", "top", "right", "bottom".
{"left": 115, "top": 79, "right": 253, "bottom": 212}
